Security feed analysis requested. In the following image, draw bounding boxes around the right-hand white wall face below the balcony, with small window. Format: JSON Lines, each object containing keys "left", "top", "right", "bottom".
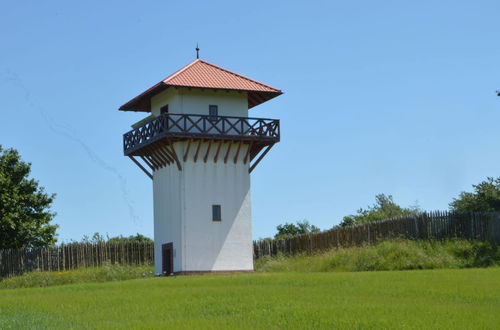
{"left": 182, "top": 143, "right": 253, "bottom": 271}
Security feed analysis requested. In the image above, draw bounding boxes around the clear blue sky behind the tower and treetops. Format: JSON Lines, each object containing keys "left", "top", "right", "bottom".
{"left": 0, "top": 1, "right": 500, "bottom": 240}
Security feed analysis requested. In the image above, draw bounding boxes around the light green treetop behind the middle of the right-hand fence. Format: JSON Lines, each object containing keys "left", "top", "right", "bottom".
{"left": 340, "top": 194, "right": 421, "bottom": 227}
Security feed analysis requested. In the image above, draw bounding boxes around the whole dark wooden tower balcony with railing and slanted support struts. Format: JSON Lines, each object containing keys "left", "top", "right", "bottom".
{"left": 123, "top": 114, "right": 280, "bottom": 178}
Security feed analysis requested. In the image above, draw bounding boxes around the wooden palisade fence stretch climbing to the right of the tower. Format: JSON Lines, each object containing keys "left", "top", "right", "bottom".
{"left": 254, "top": 211, "right": 500, "bottom": 259}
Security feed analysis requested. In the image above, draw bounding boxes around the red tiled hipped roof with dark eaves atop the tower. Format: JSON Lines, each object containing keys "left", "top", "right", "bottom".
{"left": 120, "top": 59, "right": 282, "bottom": 112}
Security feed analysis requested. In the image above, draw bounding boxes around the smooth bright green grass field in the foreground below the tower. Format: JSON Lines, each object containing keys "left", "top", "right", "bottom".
{"left": 0, "top": 267, "right": 500, "bottom": 329}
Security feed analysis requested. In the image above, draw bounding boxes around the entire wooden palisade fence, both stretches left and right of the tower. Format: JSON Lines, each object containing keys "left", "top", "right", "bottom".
{"left": 0, "top": 212, "right": 500, "bottom": 278}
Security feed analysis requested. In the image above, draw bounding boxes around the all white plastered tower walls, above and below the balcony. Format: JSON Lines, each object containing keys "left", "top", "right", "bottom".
{"left": 151, "top": 88, "right": 253, "bottom": 274}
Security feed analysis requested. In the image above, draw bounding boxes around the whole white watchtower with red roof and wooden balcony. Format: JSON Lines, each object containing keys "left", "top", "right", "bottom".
{"left": 120, "top": 59, "right": 281, "bottom": 275}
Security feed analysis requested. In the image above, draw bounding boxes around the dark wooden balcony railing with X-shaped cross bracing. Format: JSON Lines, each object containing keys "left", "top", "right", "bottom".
{"left": 123, "top": 114, "right": 280, "bottom": 156}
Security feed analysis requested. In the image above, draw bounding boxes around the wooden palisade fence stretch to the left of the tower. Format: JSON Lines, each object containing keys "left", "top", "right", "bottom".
{"left": 0, "top": 242, "right": 153, "bottom": 278}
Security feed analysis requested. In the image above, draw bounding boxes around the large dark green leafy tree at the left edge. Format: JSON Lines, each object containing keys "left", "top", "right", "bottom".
{"left": 0, "top": 145, "right": 58, "bottom": 249}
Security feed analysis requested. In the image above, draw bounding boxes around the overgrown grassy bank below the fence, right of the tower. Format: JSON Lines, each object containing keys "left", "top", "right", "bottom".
{"left": 255, "top": 239, "right": 500, "bottom": 272}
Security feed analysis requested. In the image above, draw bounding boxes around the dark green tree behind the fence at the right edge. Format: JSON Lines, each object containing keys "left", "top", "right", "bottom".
{"left": 450, "top": 177, "right": 500, "bottom": 212}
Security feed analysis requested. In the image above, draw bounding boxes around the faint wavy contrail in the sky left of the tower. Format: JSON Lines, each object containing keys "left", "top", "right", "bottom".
{"left": 0, "top": 70, "right": 142, "bottom": 226}
